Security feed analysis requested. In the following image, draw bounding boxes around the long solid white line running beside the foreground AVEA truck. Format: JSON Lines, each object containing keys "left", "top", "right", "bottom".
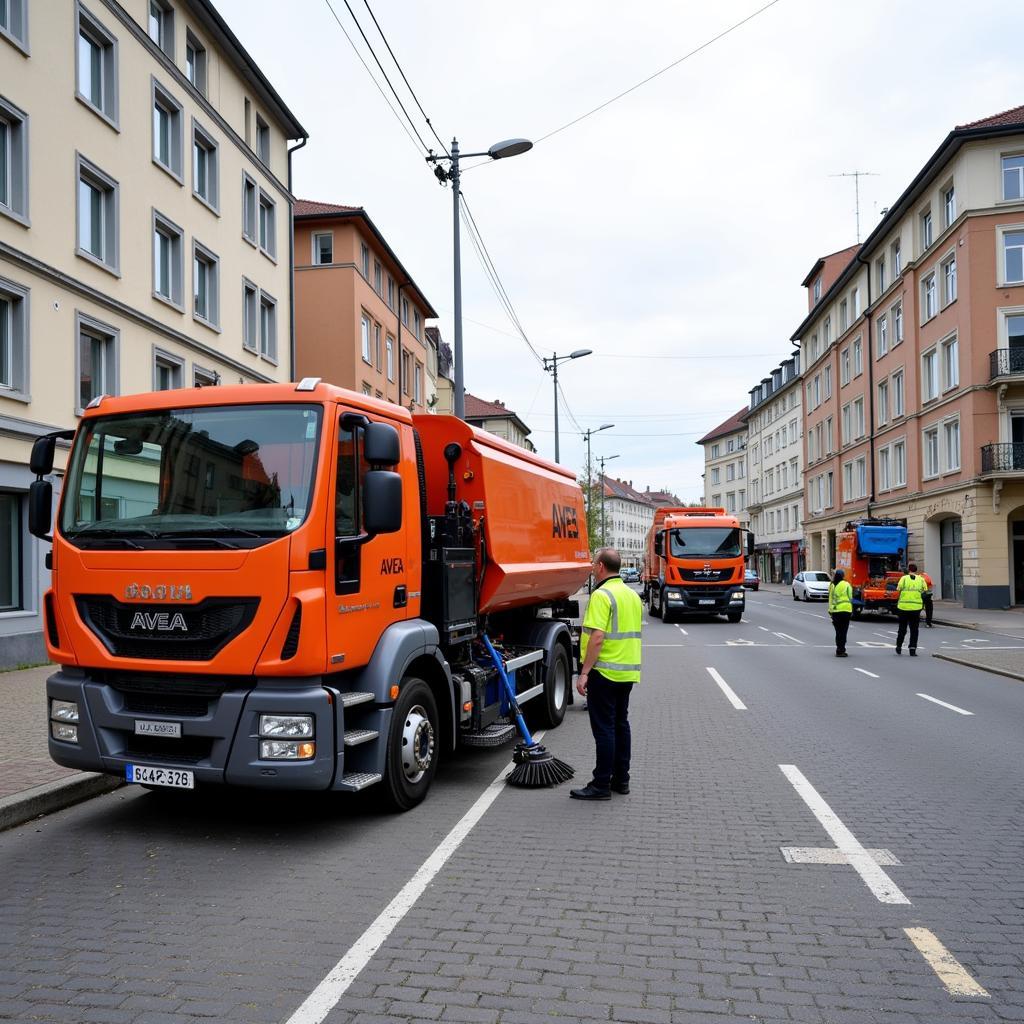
{"left": 286, "top": 732, "right": 544, "bottom": 1024}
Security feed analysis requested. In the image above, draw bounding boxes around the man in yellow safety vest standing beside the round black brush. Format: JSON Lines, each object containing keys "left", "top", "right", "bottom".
{"left": 569, "top": 548, "right": 643, "bottom": 800}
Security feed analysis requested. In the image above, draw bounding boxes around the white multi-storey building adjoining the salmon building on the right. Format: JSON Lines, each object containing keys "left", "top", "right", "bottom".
{"left": 745, "top": 351, "right": 805, "bottom": 584}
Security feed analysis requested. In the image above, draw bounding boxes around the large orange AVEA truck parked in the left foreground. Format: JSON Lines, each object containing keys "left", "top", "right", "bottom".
{"left": 30, "top": 378, "right": 590, "bottom": 809}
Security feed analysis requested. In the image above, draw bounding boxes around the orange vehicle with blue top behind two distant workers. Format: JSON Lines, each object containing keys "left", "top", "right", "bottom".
{"left": 836, "top": 519, "right": 909, "bottom": 618}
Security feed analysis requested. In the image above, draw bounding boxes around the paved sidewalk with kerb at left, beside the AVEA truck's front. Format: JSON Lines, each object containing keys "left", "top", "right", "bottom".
{"left": 0, "top": 665, "right": 121, "bottom": 829}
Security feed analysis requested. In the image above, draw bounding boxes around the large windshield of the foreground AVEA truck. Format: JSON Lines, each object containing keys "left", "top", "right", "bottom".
{"left": 60, "top": 404, "right": 322, "bottom": 547}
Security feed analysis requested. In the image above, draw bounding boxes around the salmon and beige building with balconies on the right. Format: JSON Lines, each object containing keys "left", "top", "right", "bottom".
{"left": 793, "top": 106, "right": 1024, "bottom": 607}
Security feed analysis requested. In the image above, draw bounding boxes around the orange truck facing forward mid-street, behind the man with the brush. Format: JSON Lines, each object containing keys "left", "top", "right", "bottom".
{"left": 643, "top": 507, "right": 754, "bottom": 623}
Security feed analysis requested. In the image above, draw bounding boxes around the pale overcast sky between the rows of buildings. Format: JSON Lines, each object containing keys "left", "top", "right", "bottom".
{"left": 215, "top": 0, "right": 1024, "bottom": 500}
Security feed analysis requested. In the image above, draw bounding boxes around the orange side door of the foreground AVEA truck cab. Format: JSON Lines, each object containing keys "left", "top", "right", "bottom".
{"left": 328, "top": 413, "right": 409, "bottom": 669}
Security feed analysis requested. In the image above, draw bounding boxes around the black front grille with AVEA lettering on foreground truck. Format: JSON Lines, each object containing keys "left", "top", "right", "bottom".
{"left": 75, "top": 594, "right": 259, "bottom": 662}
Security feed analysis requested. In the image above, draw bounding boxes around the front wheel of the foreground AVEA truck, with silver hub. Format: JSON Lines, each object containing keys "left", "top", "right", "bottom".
{"left": 384, "top": 678, "right": 440, "bottom": 811}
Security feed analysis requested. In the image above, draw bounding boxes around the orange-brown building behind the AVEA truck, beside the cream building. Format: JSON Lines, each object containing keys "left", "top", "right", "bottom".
{"left": 295, "top": 200, "right": 437, "bottom": 413}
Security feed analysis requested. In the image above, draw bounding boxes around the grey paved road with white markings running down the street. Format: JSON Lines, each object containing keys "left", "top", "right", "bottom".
{"left": 0, "top": 593, "right": 1024, "bottom": 1024}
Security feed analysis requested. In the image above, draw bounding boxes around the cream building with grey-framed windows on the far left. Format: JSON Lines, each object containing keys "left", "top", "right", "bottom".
{"left": 0, "top": 0, "right": 306, "bottom": 666}
